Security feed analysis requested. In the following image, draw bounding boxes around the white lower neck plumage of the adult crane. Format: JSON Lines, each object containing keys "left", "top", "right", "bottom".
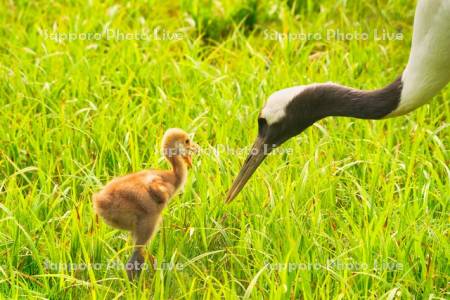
{"left": 388, "top": 0, "right": 450, "bottom": 117}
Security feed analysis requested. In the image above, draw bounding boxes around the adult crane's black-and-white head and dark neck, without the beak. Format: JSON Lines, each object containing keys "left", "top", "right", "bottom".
{"left": 259, "top": 77, "right": 402, "bottom": 146}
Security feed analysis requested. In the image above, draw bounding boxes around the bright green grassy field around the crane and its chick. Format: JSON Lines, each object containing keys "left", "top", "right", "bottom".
{"left": 0, "top": 0, "right": 450, "bottom": 299}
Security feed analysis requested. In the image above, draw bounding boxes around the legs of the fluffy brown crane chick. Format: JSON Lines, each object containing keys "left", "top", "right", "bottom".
{"left": 126, "top": 216, "right": 160, "bottom": 280}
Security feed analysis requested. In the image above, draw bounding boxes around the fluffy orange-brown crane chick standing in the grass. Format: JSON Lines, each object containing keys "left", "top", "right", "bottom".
{"left": 93, "top": 128, "right": 198, "bottom": 279}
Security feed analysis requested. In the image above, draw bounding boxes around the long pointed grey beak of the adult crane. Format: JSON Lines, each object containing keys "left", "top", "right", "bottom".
{"left": 225, "top": 137, "right": 272, "bottom": 203}
